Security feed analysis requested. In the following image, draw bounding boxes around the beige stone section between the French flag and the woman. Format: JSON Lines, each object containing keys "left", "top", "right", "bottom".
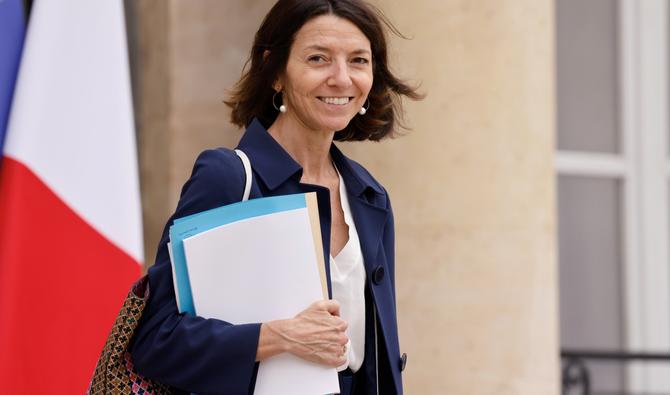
{"left": 125, "top": 0, "right": 274, "bottom": 266}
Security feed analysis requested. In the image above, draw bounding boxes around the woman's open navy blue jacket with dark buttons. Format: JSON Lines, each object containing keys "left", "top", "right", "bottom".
{"left": 131, "top": 120, "right": 406, "bottom": 395}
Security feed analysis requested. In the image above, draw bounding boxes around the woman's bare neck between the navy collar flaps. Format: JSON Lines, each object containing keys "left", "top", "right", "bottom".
{"left": 268, "top": 115, "right": 337, "bottom": 184}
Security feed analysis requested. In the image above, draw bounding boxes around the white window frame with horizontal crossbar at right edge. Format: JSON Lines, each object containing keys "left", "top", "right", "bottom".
{"left": 555, "top": 0, "right": 670, "bottom": 392}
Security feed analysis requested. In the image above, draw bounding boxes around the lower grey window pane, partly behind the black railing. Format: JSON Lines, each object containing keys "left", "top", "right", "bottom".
{"left": 558, "top": 176, "right": 624, "bottom": 393}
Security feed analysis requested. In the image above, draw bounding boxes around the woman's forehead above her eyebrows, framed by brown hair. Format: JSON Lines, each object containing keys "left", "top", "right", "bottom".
{"left": 293, "top": 15, "right": 370, "bottom": 51}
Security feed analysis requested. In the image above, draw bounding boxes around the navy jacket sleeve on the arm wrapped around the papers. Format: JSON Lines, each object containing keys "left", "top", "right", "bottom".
{"left": 131, "top": 149, "right": 260, "bottom": 394}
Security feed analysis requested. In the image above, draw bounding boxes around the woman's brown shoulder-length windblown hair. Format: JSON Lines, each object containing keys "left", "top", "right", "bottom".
{"left": 224, "top": 0, "right": 423, "bottom": 141}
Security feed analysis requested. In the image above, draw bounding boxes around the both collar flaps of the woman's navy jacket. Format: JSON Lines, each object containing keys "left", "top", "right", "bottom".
{"left": 238, "top": 118, "right": 385, "bottom": 196}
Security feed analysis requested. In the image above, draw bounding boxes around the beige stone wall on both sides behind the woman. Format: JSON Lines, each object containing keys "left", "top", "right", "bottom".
{"left": 128, "top": 0, "right": 560, "bottom": 395}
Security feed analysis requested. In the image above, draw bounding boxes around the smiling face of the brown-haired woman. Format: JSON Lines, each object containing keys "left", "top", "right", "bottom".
{"left": 278, "top": 15, "right": 372, "bottom": 132}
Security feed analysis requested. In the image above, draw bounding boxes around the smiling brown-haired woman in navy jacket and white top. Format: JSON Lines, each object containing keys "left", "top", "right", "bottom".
{"left": 132, "top": 0, "right": 419, "bottom": 394}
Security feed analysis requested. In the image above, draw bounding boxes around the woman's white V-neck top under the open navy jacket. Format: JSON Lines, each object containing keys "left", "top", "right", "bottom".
{"left": 330, "top": 169, "right": 365, "bottom": 372}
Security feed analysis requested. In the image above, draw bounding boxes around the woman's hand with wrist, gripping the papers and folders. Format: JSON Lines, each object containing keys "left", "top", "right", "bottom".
{"left": 256, "top": 300, "right": 349, "bottom": 367}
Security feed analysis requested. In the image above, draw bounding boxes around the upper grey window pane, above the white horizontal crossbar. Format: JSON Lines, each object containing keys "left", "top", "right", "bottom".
{"left": 555, "top": 0, "right": 620, "bottom": 153}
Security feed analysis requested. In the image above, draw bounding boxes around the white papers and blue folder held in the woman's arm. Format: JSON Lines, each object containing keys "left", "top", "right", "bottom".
{"left": 168, "top": 193, "right": 339, "bottom": 395}
